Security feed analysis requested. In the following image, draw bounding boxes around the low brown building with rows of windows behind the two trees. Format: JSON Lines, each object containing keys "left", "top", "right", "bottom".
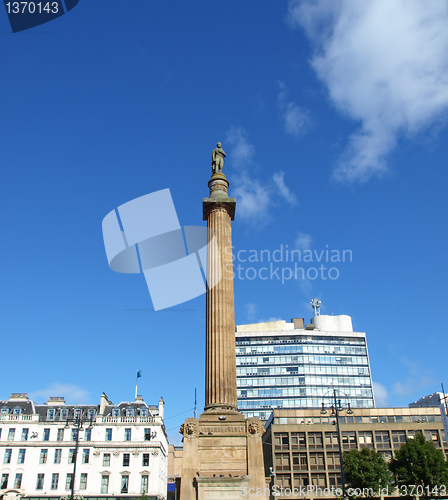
{"left": 263, "top": 402, "right": 448, "bottom": 500}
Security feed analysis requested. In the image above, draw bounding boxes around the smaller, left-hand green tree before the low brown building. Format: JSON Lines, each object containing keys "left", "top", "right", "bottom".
{"left": 343, "top": 448, "right": 390, "bottom": 494}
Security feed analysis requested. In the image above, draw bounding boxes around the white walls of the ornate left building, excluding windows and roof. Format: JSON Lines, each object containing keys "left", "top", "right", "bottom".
{"left": 0, "top": 394, "right": 168, "bottom": 498}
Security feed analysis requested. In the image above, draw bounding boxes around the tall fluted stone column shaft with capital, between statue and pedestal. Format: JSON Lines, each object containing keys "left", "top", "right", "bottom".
{"left": 203, "top": 172, "right": 237, "bottom": 412}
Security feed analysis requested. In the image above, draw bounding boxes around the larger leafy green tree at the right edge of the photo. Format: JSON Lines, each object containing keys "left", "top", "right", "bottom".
{"left": 389, "top": 432, "right": 448, "bottom": 496}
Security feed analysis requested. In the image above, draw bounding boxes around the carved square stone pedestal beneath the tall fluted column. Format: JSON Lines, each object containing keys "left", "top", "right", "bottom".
{"left": 180, "top": 410, "right": 269, "bottom": 500}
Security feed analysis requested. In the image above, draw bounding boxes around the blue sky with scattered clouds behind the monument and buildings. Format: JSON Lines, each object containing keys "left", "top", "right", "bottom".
{"left": 0, "top": 0, "right": 448, "bottom": 442}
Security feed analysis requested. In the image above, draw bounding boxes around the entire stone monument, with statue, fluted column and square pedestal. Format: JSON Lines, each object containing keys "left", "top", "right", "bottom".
{"left": 180, "top": 148, "right": 269, "bottom": 500}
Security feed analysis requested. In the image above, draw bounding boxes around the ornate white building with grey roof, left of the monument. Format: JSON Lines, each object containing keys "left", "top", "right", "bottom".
{"left": 0, "top": 393, "right": 168, "bottom": 499}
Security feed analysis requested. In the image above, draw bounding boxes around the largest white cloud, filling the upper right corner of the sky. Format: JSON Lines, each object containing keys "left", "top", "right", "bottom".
{"left": 288, "top": 0, "right": 448, "bottom": 182}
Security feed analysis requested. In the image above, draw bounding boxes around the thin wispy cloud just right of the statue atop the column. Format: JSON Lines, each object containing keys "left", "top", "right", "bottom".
{"left": 227, "top": 127, "right": 297, "bottom": 224}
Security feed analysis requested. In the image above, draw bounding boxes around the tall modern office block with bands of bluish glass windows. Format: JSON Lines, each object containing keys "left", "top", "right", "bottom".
{"left": 235, "top": 315, "right": 375, "bottom": 420}
